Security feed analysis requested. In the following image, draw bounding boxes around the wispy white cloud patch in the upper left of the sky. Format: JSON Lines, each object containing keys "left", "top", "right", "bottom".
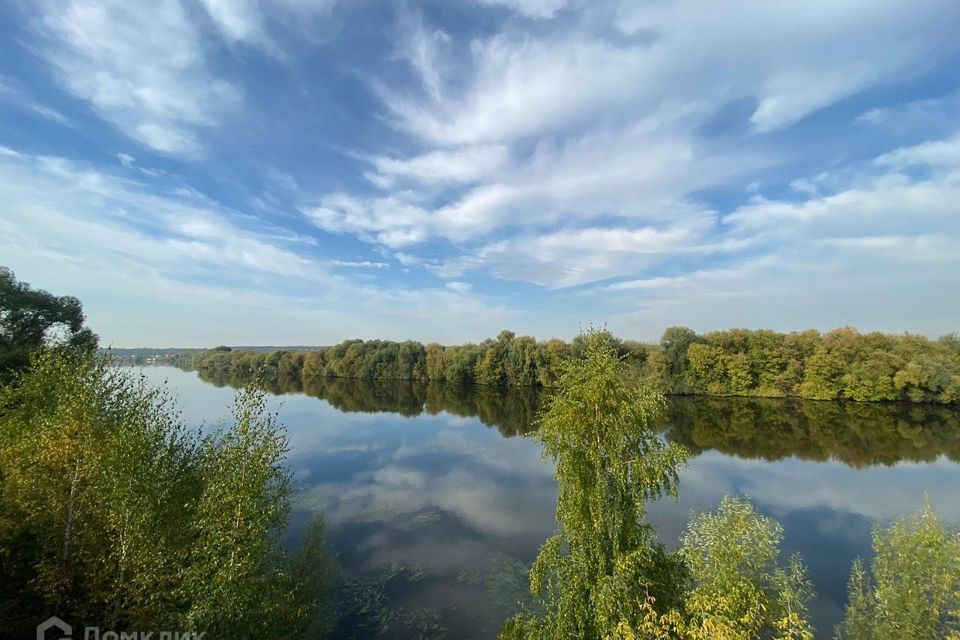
{"left": 37, "top": 0, "right": 241, "bottom": 157}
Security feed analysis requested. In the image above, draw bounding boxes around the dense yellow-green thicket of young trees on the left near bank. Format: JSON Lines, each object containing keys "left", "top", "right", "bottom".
{"left": 0, "top": 351, "right": 329, "bottom": 638}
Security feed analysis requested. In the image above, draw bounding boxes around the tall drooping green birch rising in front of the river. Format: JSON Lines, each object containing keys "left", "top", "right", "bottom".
{"left": 501, "top": 330, "right": 687, "bottom": 640}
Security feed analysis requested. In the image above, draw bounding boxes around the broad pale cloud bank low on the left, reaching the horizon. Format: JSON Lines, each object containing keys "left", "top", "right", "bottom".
{"left": 0, "top": 148, "right": 540, "bottom": 346}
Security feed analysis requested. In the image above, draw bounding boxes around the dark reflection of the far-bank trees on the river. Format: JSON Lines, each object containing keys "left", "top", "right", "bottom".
{"left": 195, "top": 364, "right": 960, "bottom": 468}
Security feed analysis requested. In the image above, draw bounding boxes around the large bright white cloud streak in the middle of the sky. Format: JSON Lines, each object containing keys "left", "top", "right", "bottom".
{"left": 312, "top": 122, "right": 768, "bottom": 256}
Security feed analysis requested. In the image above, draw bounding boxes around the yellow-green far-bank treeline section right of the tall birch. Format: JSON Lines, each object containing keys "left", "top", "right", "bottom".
{"left": 660, "top": 327, "right": 960, "bottom": 403}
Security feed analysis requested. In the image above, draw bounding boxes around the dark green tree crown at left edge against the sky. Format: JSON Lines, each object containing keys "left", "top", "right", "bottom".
{"left": 0, "top": 266, "right": 97, "bottom": 383}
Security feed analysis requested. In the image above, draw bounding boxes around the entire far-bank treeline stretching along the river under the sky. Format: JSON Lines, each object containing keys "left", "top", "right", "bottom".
{"left": 171, "top": 327, "right": 960, "bottom": 404}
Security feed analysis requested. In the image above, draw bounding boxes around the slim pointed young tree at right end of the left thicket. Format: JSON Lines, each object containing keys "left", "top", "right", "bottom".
{"left": 182, "top": 388, "right": 291, "bottom": 637}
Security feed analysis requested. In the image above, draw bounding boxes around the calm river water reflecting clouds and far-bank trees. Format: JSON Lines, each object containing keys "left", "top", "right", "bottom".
{"left": 137, "top": 367, "right": 960, "bottom": 638}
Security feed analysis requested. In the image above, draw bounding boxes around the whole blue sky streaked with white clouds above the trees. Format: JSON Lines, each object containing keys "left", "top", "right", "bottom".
{"left": 0, "top": 0, "right": 960, "bottom": 347}
